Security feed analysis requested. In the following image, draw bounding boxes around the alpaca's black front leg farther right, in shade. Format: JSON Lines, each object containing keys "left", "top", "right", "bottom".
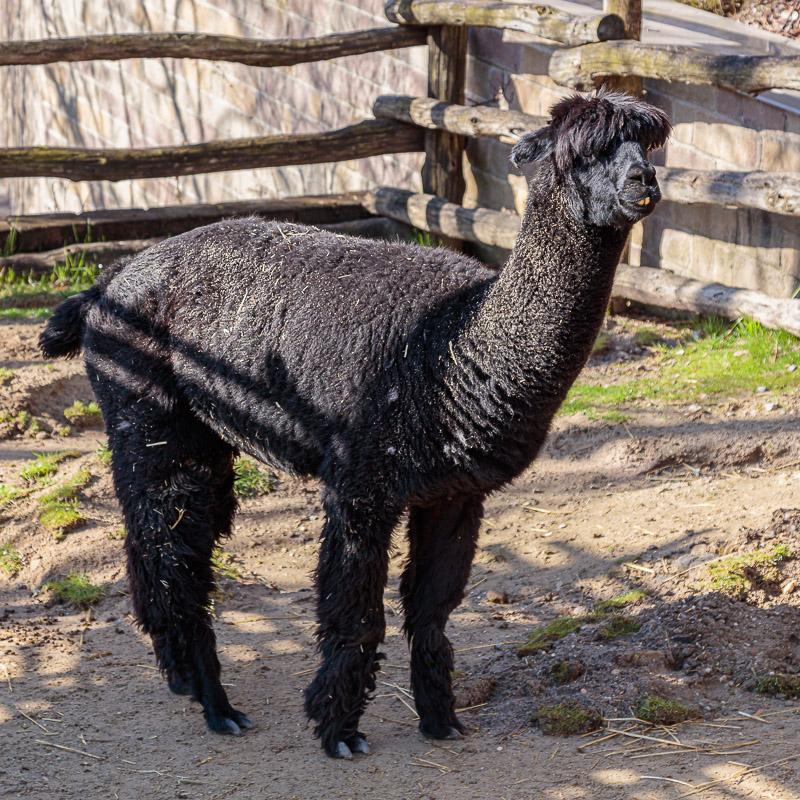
{"left": 400, "top": 497, "right": 483, "bottom": 739}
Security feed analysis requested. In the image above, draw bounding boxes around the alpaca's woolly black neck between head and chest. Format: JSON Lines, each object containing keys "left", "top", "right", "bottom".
{"left": 473, "top": 187, "right": 628, "bottom": 417}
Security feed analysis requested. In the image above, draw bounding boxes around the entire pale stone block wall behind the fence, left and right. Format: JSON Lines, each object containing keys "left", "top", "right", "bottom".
{"left": 0, "top": 0, "right": 800, "bottom": 296}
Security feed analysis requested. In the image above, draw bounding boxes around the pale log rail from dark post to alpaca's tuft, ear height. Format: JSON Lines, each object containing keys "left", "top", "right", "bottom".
{"left": 372, "top": 95, "right": 547, "bottom": 144}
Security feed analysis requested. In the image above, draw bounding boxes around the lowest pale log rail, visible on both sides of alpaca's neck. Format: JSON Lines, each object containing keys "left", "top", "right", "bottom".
{"left": 364, "top": 187, "right": 800, "bottom": 336}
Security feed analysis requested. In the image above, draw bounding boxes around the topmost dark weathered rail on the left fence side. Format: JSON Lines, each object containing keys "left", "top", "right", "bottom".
{"left": 0, "top": 26, "right": 426, "bottom": 67}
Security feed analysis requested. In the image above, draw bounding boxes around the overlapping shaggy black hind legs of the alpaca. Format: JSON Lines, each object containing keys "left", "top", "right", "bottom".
{"left": 104, "top": 401, "right": 251, "bottom": 734}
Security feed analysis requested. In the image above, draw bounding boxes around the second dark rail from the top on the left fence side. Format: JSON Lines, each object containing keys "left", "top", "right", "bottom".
{"left": 0, "top": 119, "right": 424, "bottom": 181}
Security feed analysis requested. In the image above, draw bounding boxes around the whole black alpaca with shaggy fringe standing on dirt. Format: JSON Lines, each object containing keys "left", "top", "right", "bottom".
{"left": 41, "top": 92, "right": 669, "bottom": 758}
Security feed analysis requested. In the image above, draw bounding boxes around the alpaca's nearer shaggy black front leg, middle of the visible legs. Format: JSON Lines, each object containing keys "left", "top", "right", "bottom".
{"left": 305, "top": 503, "right": 394, "bottom": 758}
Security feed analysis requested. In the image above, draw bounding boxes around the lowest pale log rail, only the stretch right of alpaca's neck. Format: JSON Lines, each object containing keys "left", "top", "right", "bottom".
{"left": 612, "top": 264, "right": 800, "bottom": 336}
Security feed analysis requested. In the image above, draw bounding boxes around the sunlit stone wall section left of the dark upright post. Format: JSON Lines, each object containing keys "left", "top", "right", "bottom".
{"left": 0, "top": 0, "right": 427, "bottom": 213}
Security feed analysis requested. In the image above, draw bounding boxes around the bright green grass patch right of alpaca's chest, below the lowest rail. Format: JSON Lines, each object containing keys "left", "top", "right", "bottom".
{"left": 561, "top": 320, "right": 800, "bottom": 414}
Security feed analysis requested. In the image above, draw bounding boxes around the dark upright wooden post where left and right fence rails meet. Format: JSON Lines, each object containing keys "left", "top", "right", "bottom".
{"left": 422, "top": 25, "right": 468, "bottom": 249}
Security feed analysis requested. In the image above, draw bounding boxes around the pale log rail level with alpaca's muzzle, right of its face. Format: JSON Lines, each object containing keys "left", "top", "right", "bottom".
{"left": 656, "top": 167, "right": 800, "bottom": 216}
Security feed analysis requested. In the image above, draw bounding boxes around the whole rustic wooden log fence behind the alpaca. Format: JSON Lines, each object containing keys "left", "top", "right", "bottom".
{"left": 0, "top": 0, "right": 800, "bottom": 335}
